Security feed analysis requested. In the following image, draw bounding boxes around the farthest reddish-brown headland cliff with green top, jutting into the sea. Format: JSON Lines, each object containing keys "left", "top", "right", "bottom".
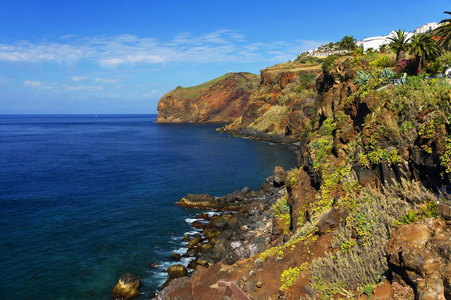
{"left": 157, "top": 73, "right": 258, "bottom": 123}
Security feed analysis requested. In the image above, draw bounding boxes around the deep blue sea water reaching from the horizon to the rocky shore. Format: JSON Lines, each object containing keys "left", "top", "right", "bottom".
{"left": 0, "top": 115, "right": 296, "bottom": 299}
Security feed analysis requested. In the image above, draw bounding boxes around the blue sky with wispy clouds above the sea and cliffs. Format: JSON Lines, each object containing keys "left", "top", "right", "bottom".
{"left": 0, "top": 0, "right": 451, "bottom": 114}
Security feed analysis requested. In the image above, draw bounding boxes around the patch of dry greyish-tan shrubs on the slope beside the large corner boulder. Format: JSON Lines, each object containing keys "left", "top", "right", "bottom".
{"left": 310, "top": 180, "right": 435, "bottom": 296}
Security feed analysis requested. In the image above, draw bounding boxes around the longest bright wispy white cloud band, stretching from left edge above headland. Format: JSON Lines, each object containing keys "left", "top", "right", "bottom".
{"left": 0, "top": 30, "right": 321, "bottom": 67}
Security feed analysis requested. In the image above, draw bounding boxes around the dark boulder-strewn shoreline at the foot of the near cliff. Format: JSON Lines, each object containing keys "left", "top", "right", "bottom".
{"left": 155, "top": 167, "right": 287, "bottom": 299}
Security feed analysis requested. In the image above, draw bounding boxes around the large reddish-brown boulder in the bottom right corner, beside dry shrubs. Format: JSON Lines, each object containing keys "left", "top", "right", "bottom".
{"left": 385, "top": 218, "right": 451, "bottom": 300}
